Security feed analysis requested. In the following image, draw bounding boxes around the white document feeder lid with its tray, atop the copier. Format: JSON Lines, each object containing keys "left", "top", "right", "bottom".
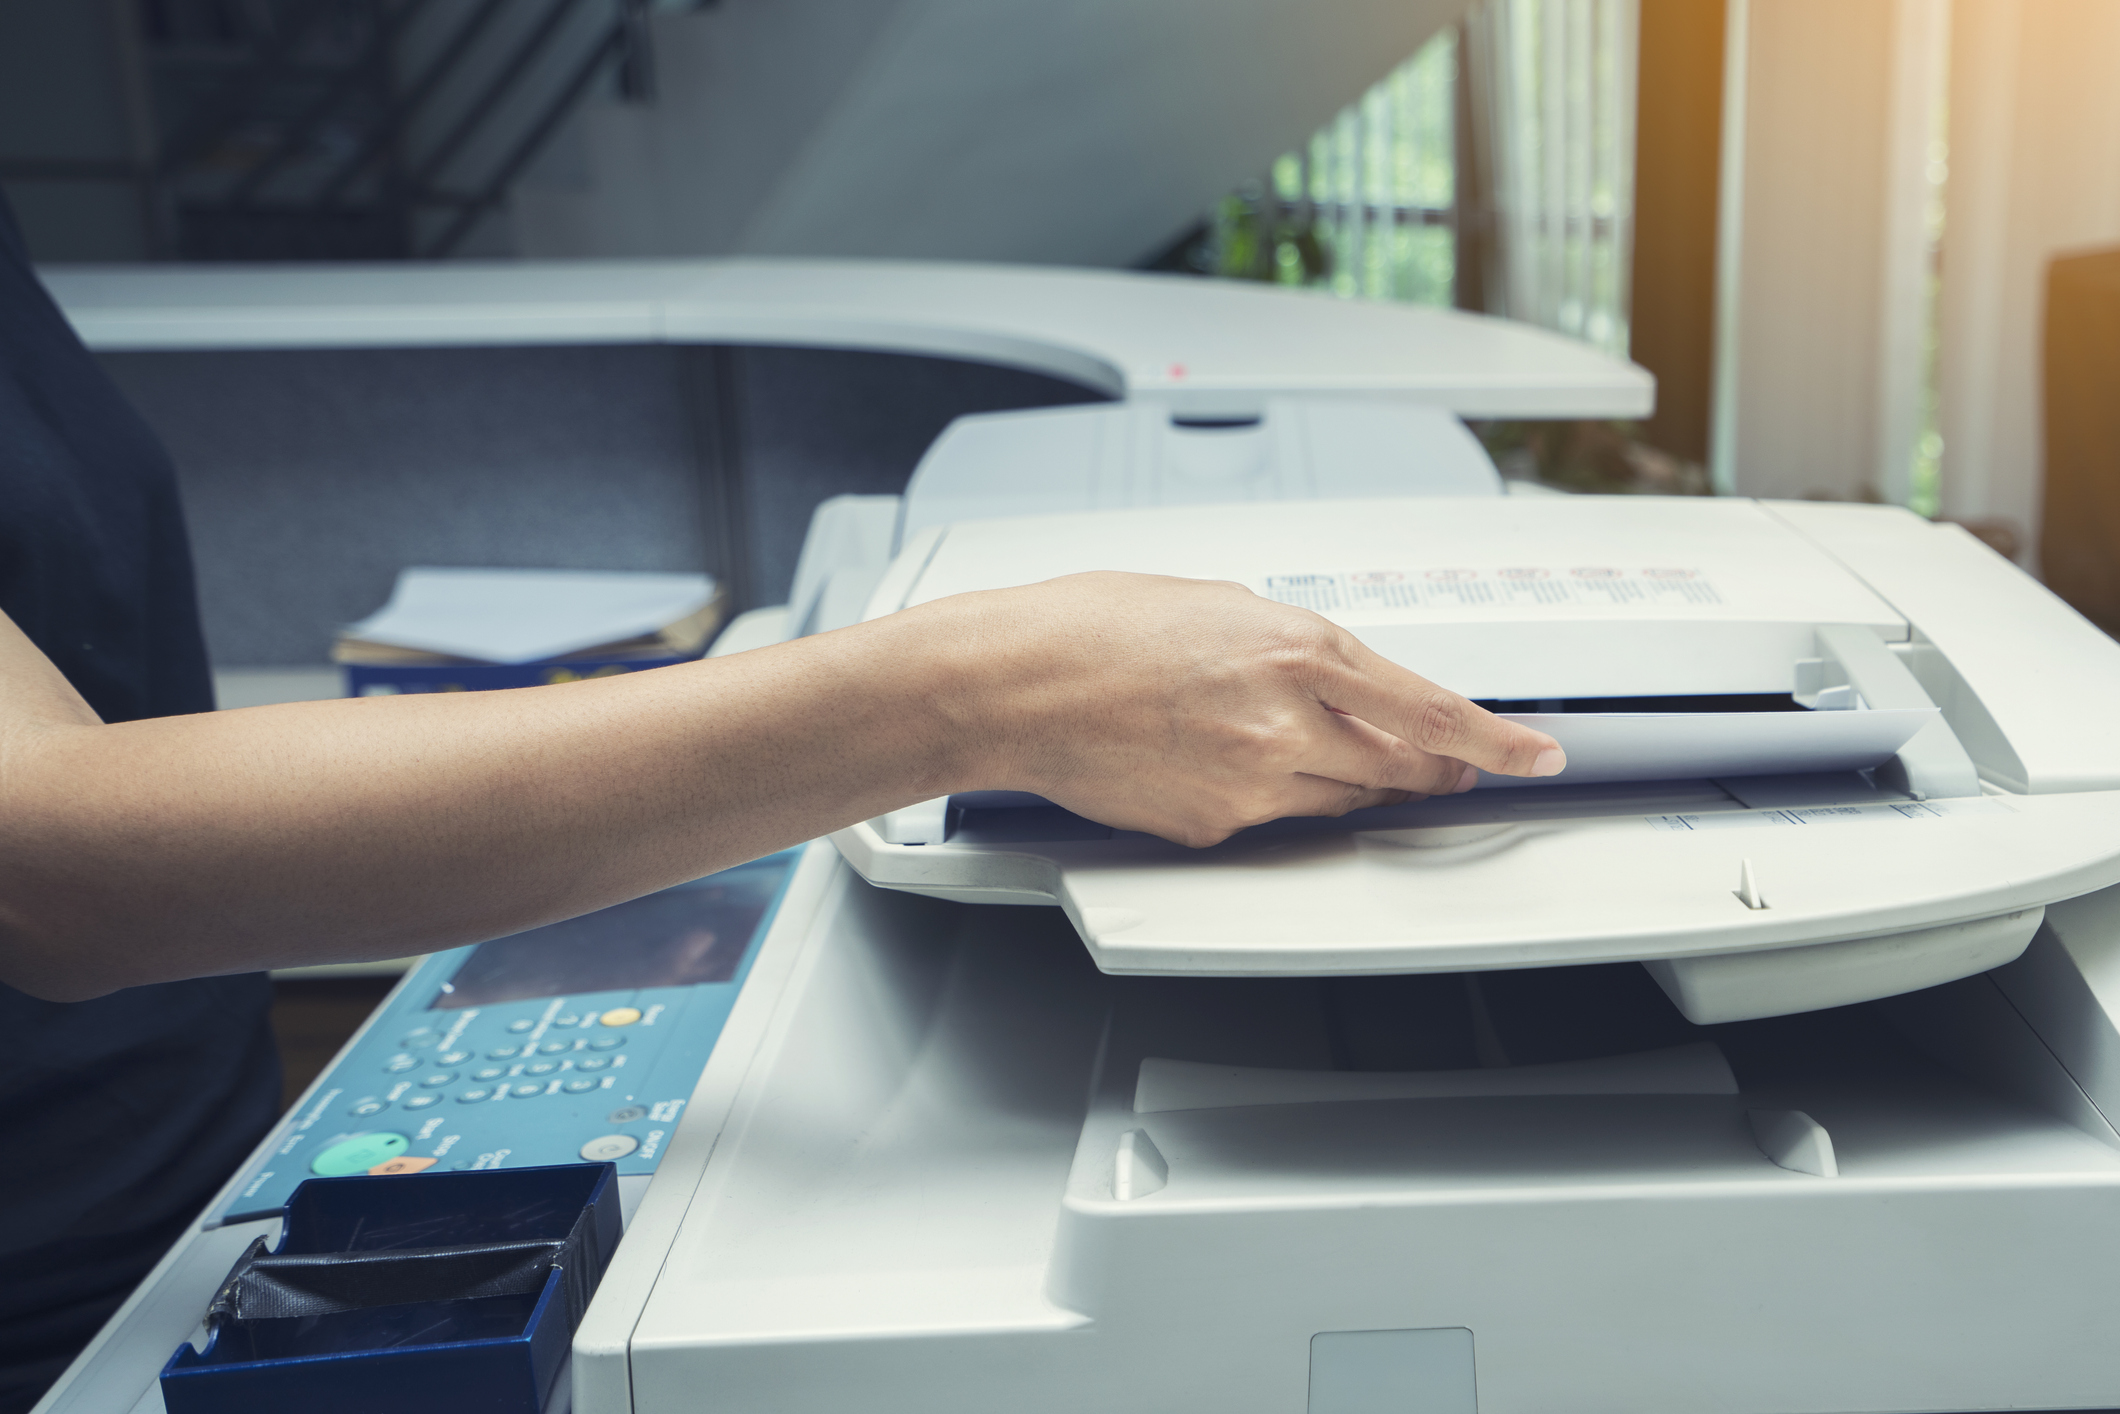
{"left": 837, "top": 498, "right": 2120, "bottom": 1022}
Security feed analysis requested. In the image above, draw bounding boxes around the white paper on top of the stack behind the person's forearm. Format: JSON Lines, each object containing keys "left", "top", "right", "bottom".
{"left": 346, "top": 566, "right": 714, "bottom": 664}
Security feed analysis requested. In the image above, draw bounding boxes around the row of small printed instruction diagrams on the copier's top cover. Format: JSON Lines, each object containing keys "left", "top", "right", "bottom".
{"left": 1266, "top": 564, "right": 1724, "bottom": 613}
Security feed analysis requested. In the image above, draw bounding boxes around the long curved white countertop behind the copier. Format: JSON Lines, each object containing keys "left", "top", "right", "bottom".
{"left": 42, "top": 261, "right": 1656, "bottom": 418}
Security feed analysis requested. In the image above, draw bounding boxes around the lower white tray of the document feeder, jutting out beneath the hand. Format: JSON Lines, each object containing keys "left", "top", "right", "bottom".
{"left": 833, "top": 780, "right": 2120, "bottom": 1020}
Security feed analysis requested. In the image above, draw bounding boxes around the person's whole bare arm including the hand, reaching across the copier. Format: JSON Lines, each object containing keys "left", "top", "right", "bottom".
{"left": 0, "top": 575, "right": 1558, "bottom": 1001}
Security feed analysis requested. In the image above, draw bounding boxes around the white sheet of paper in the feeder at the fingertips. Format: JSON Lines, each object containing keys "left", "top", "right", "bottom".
{"left": 1480, "top": 708, "right": 1938, "bottom": 786}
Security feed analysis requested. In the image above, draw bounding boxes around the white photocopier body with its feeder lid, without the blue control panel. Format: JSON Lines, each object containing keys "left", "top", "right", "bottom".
{"left": 575, "top": 489, "right": 2120, "bottom": 1414}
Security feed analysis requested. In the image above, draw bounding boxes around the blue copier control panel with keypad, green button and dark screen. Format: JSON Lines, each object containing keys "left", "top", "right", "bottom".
{"left": 216, "top": 850, "right": 801, "bottom": 1223}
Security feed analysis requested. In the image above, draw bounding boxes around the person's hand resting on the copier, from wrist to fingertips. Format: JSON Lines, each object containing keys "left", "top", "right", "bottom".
{"left": 907, "top": 572, "right": 1567, "bottom": 846}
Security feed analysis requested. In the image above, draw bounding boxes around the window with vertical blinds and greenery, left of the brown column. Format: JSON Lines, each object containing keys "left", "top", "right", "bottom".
{"left": 1181, "top": 0, "right": 1637, "bottom": 356}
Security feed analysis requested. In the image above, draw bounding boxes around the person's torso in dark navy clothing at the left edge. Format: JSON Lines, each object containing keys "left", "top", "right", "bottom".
{"left": 0, "top": 193, "right": 280, "bottom": 1410}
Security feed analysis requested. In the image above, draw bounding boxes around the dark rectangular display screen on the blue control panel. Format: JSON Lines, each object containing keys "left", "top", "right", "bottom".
{"left": 430, "top": 861, "right": 787, "bottom": 1011}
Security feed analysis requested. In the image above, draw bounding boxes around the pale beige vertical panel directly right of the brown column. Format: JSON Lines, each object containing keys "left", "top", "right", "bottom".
{"left": 1711, "top": 0, "right": 1950, "bottom": 500}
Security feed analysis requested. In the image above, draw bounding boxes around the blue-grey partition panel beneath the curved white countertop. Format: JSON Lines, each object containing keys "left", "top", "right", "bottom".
{"left": 100, "top": 343, "right": 1105, "bottom": 668}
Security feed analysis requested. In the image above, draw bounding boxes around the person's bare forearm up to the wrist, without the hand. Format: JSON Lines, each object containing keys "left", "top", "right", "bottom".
{"left": 0, "top": 615, "right": 967, "bottom": 996}
